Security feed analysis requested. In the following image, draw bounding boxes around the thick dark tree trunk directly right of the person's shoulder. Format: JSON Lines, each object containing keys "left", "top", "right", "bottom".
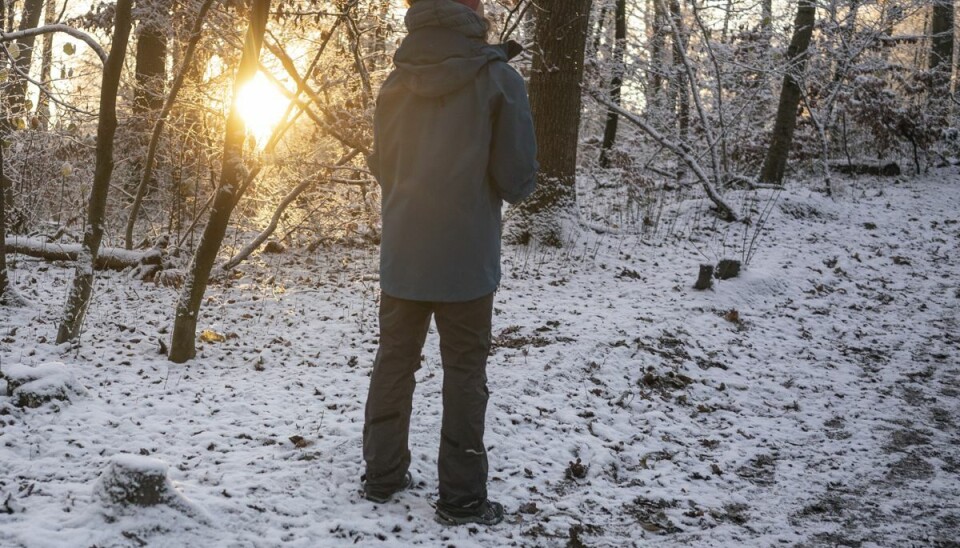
{"left": 507, "top": 0, "right": 591, "bottom": 247}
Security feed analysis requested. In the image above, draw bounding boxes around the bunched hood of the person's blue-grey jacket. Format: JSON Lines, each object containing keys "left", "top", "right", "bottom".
{"left": 393, "top": 0, "right": 522, "bottom": 97}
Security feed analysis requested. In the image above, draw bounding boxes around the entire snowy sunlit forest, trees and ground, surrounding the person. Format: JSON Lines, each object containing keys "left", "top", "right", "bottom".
{"left": 0, "top": 0, "right": 960, "bottom": 548}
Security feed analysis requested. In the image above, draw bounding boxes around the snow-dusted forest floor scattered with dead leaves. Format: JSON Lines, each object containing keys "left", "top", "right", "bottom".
{"left": 0, "top": 168, "right": 960, "bottom": 547}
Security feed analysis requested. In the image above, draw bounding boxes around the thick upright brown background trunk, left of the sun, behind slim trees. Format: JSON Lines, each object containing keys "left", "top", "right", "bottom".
{"left": 133, "top": 0, "right": 170, "bottom": 113}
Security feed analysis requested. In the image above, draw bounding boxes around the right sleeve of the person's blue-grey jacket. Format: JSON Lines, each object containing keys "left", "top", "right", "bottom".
{"left": 488, "top": 63, "right": 538, "bottom": 204}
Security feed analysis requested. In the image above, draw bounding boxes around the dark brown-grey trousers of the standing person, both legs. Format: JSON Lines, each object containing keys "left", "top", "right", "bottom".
{"left": 363, "top": 293, "right": 493, "bottom": 509}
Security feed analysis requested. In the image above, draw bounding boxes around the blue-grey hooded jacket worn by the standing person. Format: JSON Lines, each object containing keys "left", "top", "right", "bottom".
{"left": 367, "top": 0, "right": 537, "bottom": 302}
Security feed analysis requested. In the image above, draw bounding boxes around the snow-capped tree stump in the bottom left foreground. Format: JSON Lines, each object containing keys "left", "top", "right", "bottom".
{"left": 94, "top": 453, "right": 178, "bottom": 507}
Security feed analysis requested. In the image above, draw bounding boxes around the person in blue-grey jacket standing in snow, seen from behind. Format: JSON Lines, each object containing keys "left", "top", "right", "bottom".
{"left": 362, "top": 0, "right": 537, "bottom": 525}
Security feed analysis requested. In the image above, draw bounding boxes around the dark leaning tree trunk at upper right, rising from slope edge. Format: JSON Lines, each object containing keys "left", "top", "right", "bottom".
{"left": 760, "top": 0, "right": 817, "bottom": 184}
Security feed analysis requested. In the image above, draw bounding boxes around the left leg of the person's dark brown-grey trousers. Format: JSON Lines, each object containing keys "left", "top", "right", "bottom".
{"left": 363, "top": 293, "right": 431, "bottom": 489}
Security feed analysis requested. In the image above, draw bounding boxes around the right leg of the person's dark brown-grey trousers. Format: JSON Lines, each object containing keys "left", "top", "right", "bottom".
{"left": 434, "top": 293, "right": 493, "bottom": 510}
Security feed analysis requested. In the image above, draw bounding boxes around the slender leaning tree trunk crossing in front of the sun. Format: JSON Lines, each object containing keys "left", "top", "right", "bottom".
{"left": 169, "top": 0, "right": 270, "bottom": 363}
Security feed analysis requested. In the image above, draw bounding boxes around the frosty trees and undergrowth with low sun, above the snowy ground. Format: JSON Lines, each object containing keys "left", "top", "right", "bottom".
{"left": 0, "top": 0, "right": 960, "bottom": 342}
